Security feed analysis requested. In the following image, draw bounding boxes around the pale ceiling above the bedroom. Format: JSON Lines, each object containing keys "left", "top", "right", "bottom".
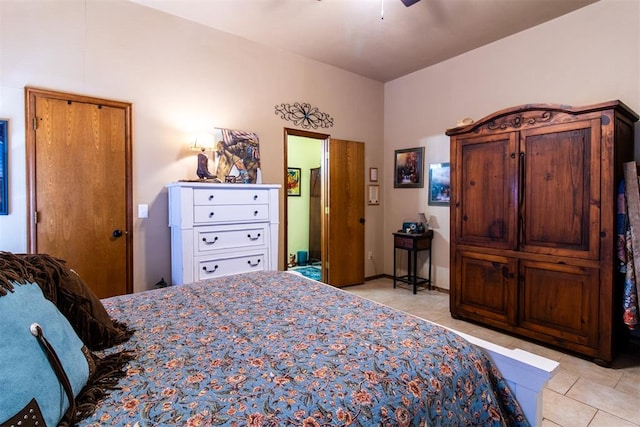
{"left": 131, "top": 0, "right": 597, "bottom": 82}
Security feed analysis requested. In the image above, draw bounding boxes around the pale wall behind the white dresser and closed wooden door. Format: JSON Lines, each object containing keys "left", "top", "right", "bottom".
{"left": 0, "top": 0, "right": 384, "bottom": 291}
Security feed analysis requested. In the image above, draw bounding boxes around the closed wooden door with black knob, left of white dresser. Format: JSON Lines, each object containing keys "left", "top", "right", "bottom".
{"left": 26, "top": 88, "right": 133, "bottom": 298}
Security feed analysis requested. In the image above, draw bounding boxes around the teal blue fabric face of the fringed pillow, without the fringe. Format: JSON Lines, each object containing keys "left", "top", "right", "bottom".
{"left": 0, "top": 283, "right": 91, "bottom": 427}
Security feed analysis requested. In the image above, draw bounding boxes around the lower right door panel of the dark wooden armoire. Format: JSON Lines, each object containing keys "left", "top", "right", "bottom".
{"left": 518, "top": 260, "right": 599, "bottom": 347}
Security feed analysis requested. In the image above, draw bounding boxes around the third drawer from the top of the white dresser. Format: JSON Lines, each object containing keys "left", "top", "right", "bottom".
{"left": 194, "top": 224, "right": 268, "bottom": 254}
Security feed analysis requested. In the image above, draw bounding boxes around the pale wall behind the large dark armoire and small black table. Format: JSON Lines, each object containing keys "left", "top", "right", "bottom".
{"left": 384, "top": 0, "right": 640, "bottom": 289}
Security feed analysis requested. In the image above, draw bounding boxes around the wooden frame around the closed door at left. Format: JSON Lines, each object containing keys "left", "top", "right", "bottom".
{"left": 25, "top": 86, "right": 133, "bottom": 293}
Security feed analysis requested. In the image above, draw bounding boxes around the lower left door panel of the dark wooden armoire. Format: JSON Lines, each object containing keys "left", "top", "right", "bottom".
{"left": 455, "top": 251, "right": 517, "bottom": 324}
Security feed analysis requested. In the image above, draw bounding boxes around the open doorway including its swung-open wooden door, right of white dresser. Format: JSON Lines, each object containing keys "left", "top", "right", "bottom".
{"left": 284, "top": 129, "right": 365, "bottom": 287}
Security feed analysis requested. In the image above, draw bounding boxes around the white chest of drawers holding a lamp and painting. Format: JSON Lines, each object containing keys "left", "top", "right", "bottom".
{"left": 167, "top": 182, "right": 280, "bottom": 285}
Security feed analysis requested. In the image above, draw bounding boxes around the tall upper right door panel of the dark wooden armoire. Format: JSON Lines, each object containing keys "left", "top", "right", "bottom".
{"left": 520, "top": 120, "right": 600, "bottom": 259}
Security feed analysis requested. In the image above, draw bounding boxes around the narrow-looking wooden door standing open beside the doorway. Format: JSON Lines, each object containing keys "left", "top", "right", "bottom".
{"left": 327, "top": 138, "right": 364, "bottom": 287}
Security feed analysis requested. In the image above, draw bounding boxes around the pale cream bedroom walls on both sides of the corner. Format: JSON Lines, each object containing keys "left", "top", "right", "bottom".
{"left": 0, "top": 0, "right": 640, "bottom": 291}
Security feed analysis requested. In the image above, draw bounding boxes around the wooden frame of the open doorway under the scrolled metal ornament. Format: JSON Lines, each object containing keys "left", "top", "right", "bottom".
{"left": 283, "top": 128, "right": 331, "bottom": 280}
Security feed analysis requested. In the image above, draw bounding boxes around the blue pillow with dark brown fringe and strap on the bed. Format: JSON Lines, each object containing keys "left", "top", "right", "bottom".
{"left": 0, "top": 282, "right": 134, "bottom": 426}
